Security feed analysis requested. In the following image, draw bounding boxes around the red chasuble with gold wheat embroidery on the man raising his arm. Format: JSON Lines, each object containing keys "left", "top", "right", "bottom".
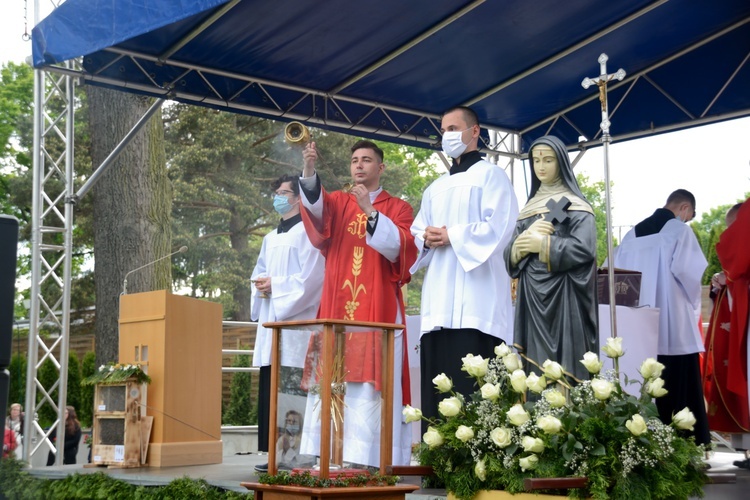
{"left": 302, "top": 186, "right": 417, "bottom": 404}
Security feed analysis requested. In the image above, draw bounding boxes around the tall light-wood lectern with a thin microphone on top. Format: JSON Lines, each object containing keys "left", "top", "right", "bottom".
{"left": 119, "top": 290, "right": 222, "bottom": 467}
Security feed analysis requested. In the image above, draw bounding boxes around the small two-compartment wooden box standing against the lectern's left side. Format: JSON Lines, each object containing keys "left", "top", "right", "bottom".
{"left": 91, "top": 378, "right": 151, "bottom": 468}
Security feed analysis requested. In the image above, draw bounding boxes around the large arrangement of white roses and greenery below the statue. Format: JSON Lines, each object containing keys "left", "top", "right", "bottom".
{"left": 412, "top": 339, "right": 706, "bottom": 500}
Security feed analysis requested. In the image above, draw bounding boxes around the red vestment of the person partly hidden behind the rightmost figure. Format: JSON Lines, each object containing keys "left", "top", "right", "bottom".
{"left": 703, "top": 287, "right": 750, "bottom": 433}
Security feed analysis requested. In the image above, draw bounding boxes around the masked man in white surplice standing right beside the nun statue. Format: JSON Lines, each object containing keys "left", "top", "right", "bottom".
{"left": 411, "top": 106, "right": 518, "bottom": 432}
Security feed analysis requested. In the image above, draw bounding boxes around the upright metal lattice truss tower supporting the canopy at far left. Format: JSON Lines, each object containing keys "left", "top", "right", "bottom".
{"left": 23, "top": 37, "right": 75, "bottom": 465}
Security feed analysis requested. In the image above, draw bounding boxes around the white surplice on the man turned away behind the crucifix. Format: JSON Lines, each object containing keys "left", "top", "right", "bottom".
{"left": 615, "top": 219, "right": 708, "bottom": 356}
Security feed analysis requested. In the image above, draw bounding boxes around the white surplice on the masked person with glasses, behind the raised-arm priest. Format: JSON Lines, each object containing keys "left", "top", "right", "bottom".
{"left": 250, "top": 222, "right": 325, "bottom": 368}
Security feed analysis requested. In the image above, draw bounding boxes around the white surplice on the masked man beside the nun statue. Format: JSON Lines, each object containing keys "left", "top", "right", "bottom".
{"left": 411, "top": 161, "right": 518, "bottom": 344}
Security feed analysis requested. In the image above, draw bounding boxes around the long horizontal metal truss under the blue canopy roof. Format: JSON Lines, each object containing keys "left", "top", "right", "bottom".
{"left": 45, "top": 48, "right": 519, "bottom": 162}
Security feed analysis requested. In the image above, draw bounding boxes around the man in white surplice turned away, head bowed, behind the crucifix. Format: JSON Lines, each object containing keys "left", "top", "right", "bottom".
{"left": 614, "top": 189, "right": 711, "bottom": 444}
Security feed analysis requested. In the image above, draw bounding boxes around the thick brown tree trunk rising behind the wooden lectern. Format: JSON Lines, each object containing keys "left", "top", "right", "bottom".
{"left": 86, "top": 86, "right": 172, "bottom": 364}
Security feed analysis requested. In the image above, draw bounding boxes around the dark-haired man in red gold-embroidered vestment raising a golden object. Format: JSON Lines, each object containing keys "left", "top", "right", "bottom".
{"left": 300, "top": 141, "right": 416, "bottom": 466}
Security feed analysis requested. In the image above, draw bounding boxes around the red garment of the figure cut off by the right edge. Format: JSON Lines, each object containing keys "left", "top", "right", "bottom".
{"left": 716, "top": 201, "right": 750, "bottom": 399}
